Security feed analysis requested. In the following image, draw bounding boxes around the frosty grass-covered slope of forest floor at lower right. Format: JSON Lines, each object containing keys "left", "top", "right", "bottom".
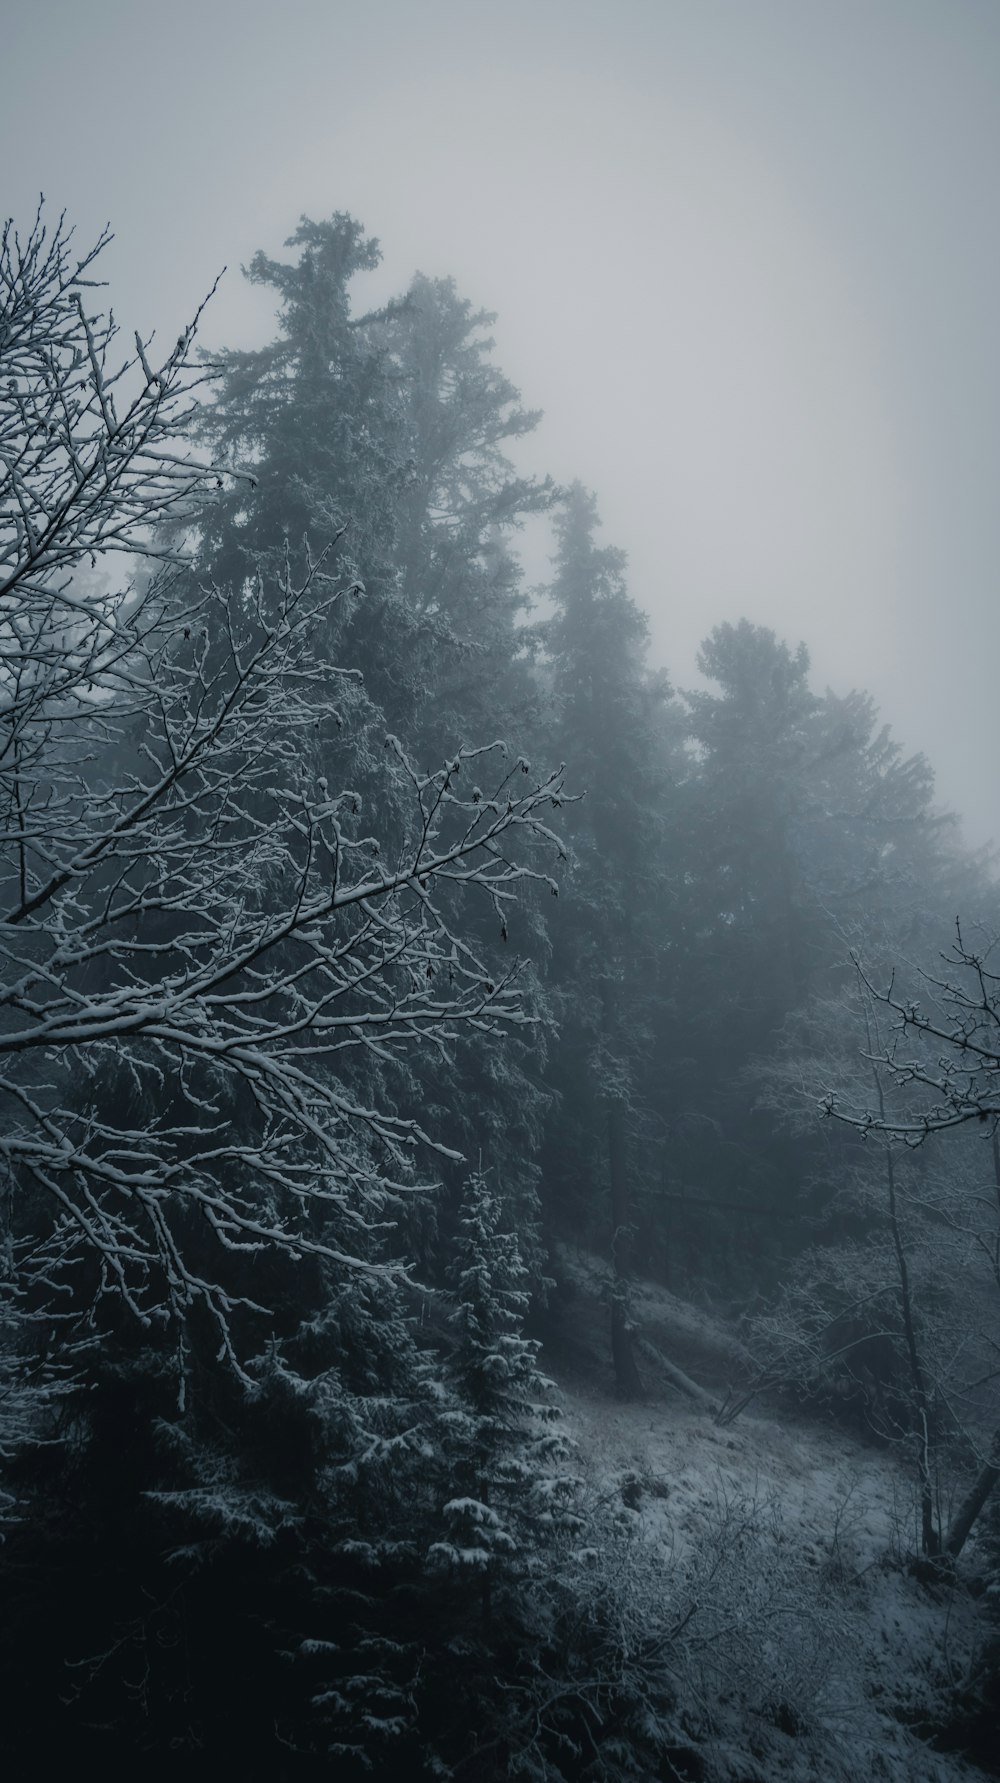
{"left": 542, "top": 1250, "right": 1000, "bottom": 1783}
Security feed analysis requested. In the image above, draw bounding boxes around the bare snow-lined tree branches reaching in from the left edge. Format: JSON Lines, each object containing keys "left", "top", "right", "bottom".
{"left": 0, "top": 205, "right": 560, "bottom": 1348}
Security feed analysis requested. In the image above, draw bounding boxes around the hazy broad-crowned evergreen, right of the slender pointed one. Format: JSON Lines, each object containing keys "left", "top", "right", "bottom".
{"left": 665, "top": 622, "right": 984, "bottom": 1294}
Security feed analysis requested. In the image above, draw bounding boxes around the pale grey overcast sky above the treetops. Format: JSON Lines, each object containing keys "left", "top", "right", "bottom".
{"left": 0, "top": 0, "right": 1000, "bottom": 843}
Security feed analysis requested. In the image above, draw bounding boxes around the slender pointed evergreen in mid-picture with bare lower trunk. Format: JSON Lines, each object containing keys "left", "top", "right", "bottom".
{"left": 544, "top": 485, "right": 677, "bottom": 1394}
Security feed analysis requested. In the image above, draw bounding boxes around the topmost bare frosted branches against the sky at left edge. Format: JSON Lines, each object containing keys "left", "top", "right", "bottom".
{"left": 0, "top": 207, "right": 237, "bottom": 609}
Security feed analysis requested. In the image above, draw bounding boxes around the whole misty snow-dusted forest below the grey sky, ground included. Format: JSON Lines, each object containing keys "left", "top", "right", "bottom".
{"left": 0, "top": 209, "right": 1000, "bottom": 1783}
